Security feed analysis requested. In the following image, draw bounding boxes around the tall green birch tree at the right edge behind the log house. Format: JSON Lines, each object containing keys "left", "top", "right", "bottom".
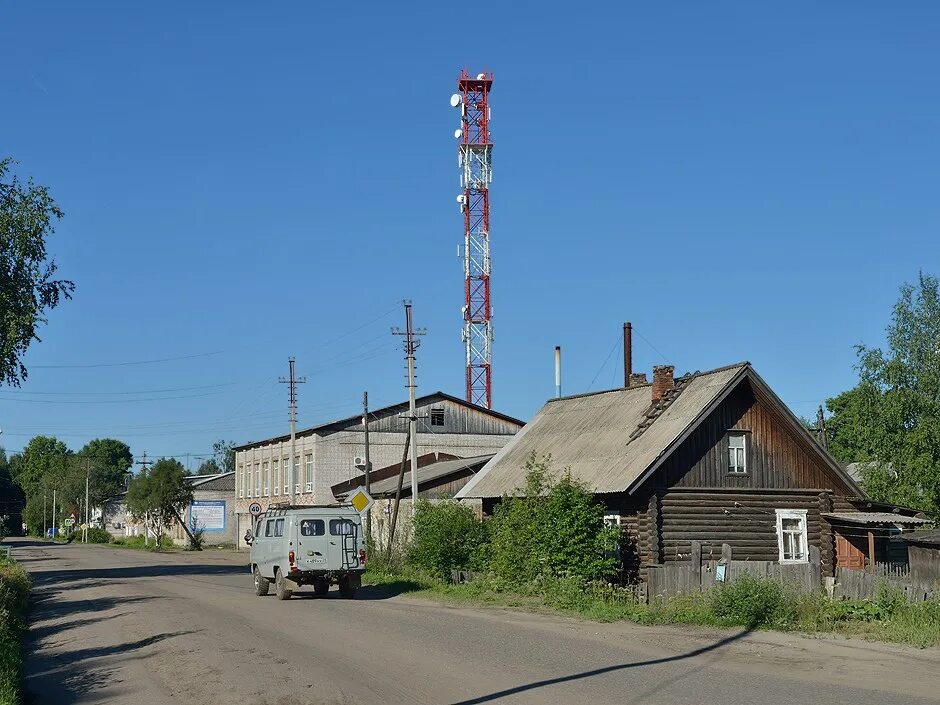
{"left": 843, "top": 272, "right": 940, "bottom": 515}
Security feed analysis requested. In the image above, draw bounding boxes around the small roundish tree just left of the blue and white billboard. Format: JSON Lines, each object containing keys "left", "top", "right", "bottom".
{"left": 126, "top": 458, "right": 193, "bottom": 546}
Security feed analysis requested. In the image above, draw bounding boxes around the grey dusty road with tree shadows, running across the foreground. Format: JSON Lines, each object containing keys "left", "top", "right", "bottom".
{"left": 14, "top": 540, "right": 940, "bottom": 705}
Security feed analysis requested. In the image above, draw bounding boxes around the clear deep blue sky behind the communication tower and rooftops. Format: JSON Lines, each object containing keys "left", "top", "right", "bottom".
{"left": 0, "top": 0, "right": 940, "bottom": 464}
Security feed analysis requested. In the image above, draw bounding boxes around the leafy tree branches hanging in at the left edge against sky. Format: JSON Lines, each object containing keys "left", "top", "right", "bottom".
{"left": 0, "top": 158, "right": 75, "bottom": 387}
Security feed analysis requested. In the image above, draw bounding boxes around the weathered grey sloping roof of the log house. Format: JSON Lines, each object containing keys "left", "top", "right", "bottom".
{"left": 457, "top": 362, "right": 863, "bottom": 498}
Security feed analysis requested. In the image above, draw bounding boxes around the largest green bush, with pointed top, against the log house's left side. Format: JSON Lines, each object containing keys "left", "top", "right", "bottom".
{"left": 489, "top": 453, "right": 618, "bottom": 585}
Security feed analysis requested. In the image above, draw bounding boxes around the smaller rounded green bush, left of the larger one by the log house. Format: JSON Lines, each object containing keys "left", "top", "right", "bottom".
{"left": 408, "top": 500, "right": 487, "bottom": 578}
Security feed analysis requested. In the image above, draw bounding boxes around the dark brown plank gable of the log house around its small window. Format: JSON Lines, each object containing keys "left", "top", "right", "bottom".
{"left": 648, "top": 376, "right": 857, "bottom": 496}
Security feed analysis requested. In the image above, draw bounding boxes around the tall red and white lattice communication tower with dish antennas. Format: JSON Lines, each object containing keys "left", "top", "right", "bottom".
{"left": 450, "top": 71, "right": 493, "bottom": 409}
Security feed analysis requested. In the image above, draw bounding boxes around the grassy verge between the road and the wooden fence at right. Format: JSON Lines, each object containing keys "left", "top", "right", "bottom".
{"left": 366, "top": 569, "right": 940, "bottom": 648}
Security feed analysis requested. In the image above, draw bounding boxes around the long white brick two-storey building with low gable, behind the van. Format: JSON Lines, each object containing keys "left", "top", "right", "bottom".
{"left": 228, "top": 392, "right": 523, "bottom": 545}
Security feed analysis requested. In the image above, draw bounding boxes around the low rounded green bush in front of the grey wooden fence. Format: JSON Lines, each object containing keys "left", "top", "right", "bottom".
{"left": 709, "top": 575, "right": 796, "bottom": 628}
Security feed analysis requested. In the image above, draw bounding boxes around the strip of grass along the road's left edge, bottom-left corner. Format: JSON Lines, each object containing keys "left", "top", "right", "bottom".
{"left": 0, "top": 558, "right": 30, "bottom": 705}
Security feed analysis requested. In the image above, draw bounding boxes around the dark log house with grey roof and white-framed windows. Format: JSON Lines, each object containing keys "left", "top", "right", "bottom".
{"left": 457, "top": 362, "right": 925, "bottom": 578}
